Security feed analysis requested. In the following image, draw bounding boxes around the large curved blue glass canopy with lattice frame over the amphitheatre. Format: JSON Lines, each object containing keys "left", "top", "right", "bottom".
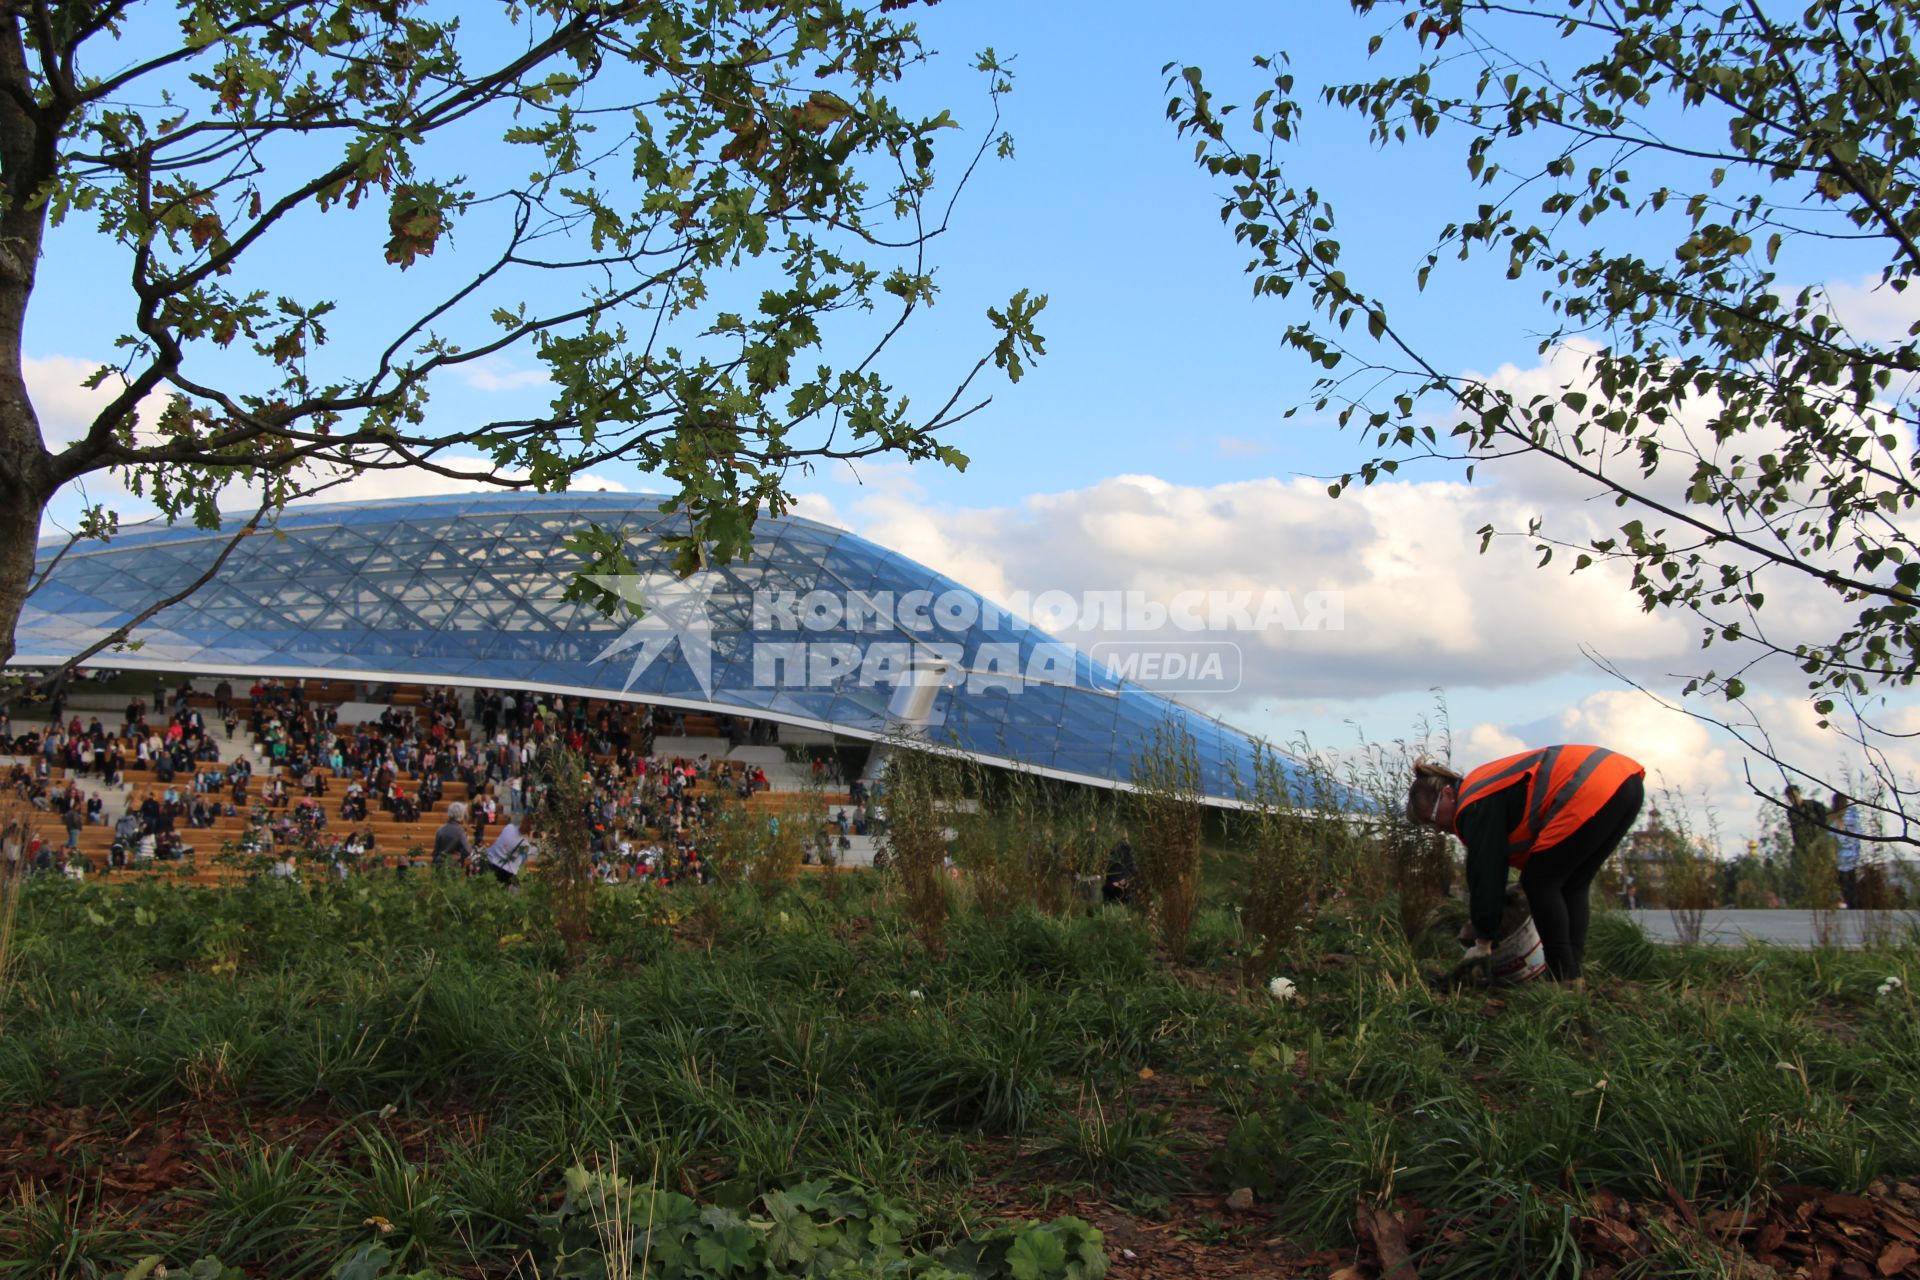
{"left": 13, "top": 493, "right": 1294, "bottom": 800}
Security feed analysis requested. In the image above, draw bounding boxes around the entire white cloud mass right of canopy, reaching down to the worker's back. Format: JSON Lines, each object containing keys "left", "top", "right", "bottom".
{"left": 821, "top": 460, "right": 1920, "bottom": 839}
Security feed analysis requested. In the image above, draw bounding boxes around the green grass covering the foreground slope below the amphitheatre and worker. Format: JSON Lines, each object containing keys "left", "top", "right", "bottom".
{"left": 0, "top": 877, "right": 1920, "bottom": 1278}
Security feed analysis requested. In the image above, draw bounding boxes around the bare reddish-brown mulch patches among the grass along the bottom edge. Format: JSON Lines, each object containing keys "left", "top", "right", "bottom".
{"left": 0, "top": 1077, "right": 1920, "bottom": 1280}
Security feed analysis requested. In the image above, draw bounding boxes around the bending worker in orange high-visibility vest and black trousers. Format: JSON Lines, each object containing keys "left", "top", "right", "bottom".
{"left": 1407, "top": 745, "right": 1647, "bottom": 983}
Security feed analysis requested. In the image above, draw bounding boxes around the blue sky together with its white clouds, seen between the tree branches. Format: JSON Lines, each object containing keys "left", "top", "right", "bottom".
{"left": 29, "top": 0, "right": 1904, "bottom": 841}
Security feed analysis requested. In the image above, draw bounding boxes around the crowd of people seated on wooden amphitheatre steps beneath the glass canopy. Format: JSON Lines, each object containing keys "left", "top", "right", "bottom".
{"left": 0, "top": 679, "right": 868, "bottom": 885}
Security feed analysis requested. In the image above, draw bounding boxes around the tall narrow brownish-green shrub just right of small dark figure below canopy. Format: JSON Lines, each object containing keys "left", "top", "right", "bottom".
{"left": 1133, "top": 718, "right": 1206, "bottom": 960}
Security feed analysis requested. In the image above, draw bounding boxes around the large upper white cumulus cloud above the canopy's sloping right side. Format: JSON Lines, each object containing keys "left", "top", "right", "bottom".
{"left": 833, "top": 476, "right": 1693, "bottom": 699}
